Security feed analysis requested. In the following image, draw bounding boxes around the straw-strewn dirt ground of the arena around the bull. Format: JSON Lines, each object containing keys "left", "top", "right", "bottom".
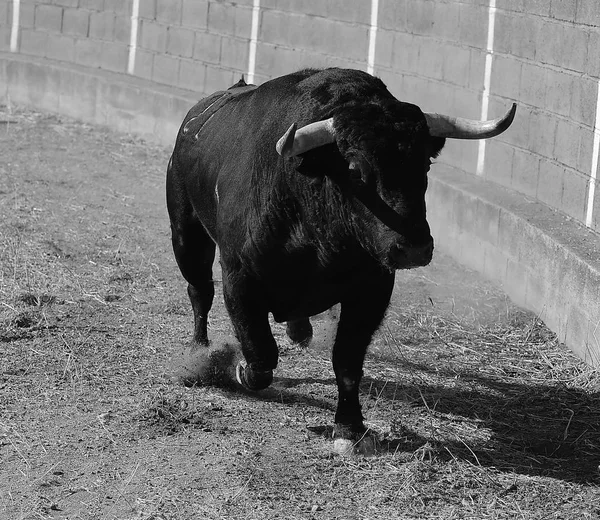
{"left": 0, "top": 107, "right": 600, "bottom": 520}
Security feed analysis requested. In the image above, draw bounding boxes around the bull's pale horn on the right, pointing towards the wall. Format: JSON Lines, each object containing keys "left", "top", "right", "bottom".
{"left": 425, "top": 103, "right": 517, "bottom": 139}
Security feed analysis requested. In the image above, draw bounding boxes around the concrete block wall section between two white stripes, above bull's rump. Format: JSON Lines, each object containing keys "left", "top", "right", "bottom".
{"left": 134, "top": 0, "right": 252, "bottom": 93}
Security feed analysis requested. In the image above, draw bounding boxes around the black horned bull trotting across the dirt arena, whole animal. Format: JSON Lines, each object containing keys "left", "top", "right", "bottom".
{"left": 167, "top": 69, "right": 515, "bottom": 450}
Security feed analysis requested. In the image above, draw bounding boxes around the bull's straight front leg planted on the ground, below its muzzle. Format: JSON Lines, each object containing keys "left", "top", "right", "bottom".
{"left": 332, "top": 273, "right": 394, "bottom": 452}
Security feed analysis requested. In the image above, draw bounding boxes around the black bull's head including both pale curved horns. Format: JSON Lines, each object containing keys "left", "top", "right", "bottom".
{"left": 276, "top": 99, "right": 516, "bottom": 270}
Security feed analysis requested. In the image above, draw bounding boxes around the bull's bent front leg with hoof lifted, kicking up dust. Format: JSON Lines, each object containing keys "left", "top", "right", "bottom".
{"left": 223, "top": 276, "right": 279, "bottom": 391}
